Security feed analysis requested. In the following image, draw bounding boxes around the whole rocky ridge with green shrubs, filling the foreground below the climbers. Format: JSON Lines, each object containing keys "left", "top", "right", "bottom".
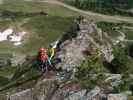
{"left": 1, "top": 16, "right": 133, "bottom": 100}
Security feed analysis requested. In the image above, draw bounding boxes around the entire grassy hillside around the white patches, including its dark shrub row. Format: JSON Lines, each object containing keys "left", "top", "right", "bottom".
{"left": 0, "top": 0, "right": 77, "bottom": 62}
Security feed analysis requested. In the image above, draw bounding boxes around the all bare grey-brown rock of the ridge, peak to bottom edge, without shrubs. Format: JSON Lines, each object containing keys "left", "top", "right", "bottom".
{"left": 6, "top": 19, "right": 127, "bottom": 100}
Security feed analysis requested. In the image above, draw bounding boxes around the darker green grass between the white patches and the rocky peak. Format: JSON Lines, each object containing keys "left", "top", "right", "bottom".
{"left": 22, "top": 16, "right": 73, "bottom": 53}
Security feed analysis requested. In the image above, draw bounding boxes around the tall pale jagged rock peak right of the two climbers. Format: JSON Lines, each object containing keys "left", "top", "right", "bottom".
{"left": 57, "top": 20, "right": 114, "bottom": 70}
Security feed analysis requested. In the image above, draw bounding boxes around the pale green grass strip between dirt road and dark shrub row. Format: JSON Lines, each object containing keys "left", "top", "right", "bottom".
{"left": 0, "top": 0, "right": 77, "bottom": 17}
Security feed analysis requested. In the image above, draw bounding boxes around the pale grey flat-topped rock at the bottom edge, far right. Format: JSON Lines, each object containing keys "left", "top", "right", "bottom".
{"left": 108, "top": 94, "right": 127, "bottom": 100}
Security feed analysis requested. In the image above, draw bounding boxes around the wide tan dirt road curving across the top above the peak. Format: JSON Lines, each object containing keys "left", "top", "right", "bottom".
{"left": 29, "top": 0, "right": 133, "bottom": 23}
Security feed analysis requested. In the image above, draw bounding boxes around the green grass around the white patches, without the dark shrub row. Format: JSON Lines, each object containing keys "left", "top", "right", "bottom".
{"left": 0, "top": 1, "right": 77, "bottom": 53}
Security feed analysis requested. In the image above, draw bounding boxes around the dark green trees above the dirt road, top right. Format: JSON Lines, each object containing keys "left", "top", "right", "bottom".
{"left": 64, "top": 0, "right": 133, "bottom": 16}
